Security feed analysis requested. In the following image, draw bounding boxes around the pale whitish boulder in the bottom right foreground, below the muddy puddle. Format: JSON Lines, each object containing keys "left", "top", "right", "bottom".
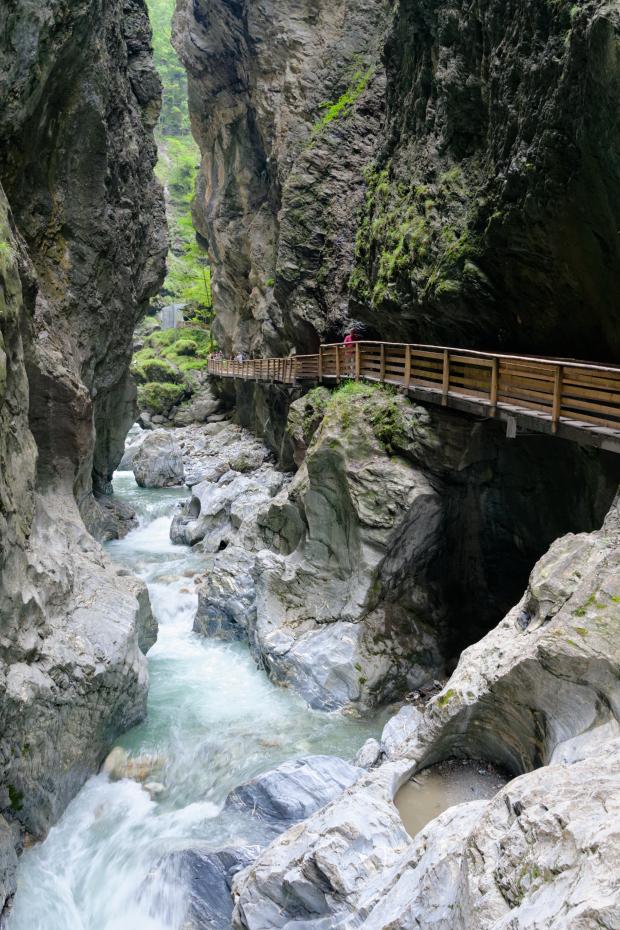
{"left": 233, "top": 740, "right": 620, "bottom": 930}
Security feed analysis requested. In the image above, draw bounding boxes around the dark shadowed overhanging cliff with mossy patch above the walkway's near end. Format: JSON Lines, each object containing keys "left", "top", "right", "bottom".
{"left": 352, "top": 0, "right": 620, "bottom": 361}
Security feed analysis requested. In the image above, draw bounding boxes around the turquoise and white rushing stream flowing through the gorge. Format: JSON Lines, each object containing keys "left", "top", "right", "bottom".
{"left": 9, "top": 473, "right": 381, "bottom": 930}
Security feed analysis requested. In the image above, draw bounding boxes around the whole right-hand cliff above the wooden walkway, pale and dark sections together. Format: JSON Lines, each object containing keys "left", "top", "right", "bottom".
{"left": 176, "top": 0, "right": 620, "bottom": 360}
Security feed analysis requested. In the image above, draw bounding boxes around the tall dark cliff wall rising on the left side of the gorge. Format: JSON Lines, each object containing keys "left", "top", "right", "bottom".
{"left": 0, "top": 0, "right": 166, "bottom": 496}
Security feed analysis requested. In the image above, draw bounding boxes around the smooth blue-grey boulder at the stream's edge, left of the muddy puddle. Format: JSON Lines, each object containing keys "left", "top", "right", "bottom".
{"left": 226, "top": 756, "right": 362, "bottom": 830}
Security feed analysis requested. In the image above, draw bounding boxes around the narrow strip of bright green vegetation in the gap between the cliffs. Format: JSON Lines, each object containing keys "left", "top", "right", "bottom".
{"left": 148, "top": 0, "right": 212, "bottom": 323}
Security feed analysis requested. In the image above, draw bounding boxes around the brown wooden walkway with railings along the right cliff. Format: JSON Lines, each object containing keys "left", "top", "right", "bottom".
{"left": 208, "top": 342, "right": 620, "bottom": 452}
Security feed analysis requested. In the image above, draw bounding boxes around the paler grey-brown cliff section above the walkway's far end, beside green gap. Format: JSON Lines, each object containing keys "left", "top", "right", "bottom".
{"left": 175, "top": 0, "right": 391, "bottom": 352}
